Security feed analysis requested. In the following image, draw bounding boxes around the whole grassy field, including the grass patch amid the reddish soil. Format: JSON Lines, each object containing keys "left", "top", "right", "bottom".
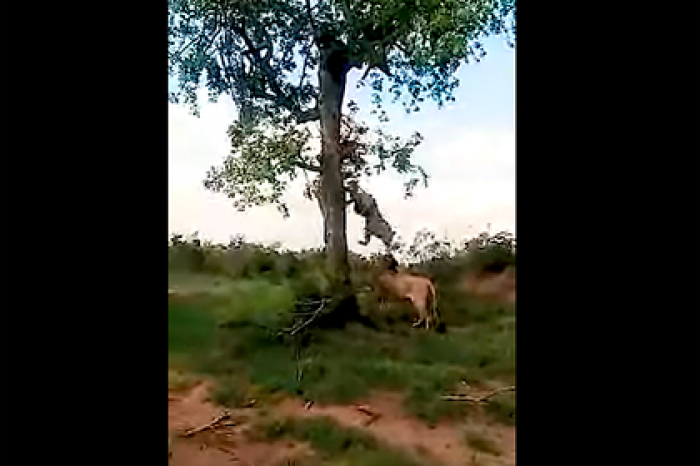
{"left": 168, "top": 235, "right": 516, "bottom": 466}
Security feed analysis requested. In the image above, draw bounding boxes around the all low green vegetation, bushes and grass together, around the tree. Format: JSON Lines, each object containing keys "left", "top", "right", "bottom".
{"left": 168, "top": 232, "right": 516, "bottom": 436}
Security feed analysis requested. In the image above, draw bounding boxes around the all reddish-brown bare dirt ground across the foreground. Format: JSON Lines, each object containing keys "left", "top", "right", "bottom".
{"left": 168, "top": 382, "right": 515, "bottom": 466}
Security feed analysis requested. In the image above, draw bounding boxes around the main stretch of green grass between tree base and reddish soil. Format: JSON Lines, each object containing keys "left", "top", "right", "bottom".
{"left": 168, "top": 272, "right": 515, "bottom": 424}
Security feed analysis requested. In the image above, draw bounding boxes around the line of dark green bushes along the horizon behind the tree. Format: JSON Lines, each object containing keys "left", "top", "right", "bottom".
{"left": 168, "top": 230, "right": 516, "bottom": 330}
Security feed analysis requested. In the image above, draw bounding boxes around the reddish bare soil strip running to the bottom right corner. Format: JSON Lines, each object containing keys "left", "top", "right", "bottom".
{"left": 277, "top": 393, "right": 515, "bottom": 466}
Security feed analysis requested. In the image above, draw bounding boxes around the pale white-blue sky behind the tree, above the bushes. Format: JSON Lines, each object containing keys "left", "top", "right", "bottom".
{"left": 168, "top": 38, "right": 515, "bottom": 254}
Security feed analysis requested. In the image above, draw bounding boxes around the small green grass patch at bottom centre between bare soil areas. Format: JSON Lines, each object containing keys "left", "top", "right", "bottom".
{"left": 258, "top": 417, "right": 419, "bottom": 466}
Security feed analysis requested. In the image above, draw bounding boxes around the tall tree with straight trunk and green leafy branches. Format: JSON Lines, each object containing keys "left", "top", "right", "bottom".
{"left": 168, "top": 0, "right": 515, "bottom": 316}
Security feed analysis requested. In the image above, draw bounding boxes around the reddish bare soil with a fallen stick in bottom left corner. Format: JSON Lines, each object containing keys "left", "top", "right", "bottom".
{"left": 168, "top": 382, "right": 313, "bottom": 466}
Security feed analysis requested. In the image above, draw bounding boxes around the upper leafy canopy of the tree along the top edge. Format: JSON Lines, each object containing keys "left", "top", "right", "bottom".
{"left": 168, "top": 0, "right": 515, "bottom": 116}
